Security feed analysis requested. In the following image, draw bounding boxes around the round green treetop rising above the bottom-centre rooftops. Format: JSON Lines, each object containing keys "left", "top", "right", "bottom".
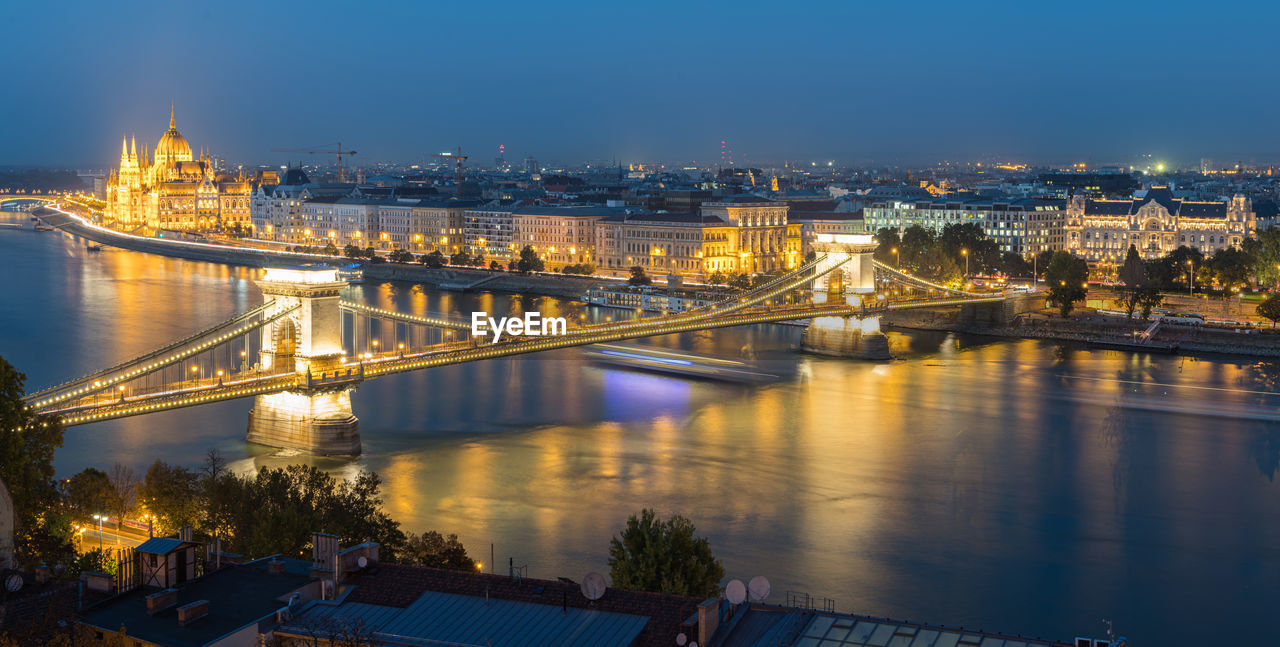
{"left": 609, "top": 509, "right": 724, "bottom": 596}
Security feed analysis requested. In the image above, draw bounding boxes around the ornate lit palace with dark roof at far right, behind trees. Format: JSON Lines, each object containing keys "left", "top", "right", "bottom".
{"left": 1064, "top": 186, "right": 1257, "bottom": 263}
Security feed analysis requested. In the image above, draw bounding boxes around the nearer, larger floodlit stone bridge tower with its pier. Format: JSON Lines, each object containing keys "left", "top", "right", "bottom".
{"left": 248, "top": 265, "right": 360, "bottom": 455}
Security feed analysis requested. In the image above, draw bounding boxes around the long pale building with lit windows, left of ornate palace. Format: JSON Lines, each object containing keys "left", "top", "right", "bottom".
{"left": 863, "top": 197, "right": 1066, "bottom": 255}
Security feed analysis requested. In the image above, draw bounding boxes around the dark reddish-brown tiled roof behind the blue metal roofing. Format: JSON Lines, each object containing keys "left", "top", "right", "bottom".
{"left": 346, "top": 564, "right": 701, "bottom": 644}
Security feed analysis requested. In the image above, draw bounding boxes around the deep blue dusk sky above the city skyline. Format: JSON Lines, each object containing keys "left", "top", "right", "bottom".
{"left": 0, "top": 0, "right": 1280, "bottom": 167}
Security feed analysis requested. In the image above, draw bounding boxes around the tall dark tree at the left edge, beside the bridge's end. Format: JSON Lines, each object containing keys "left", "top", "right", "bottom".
{"left": 0, "top": 357, "right": 63, "bottom": 552}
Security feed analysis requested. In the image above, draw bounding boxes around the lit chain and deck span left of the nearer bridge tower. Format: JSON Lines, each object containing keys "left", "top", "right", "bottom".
{"left": 27, "top": 304, "right": 297, "bottom": 415}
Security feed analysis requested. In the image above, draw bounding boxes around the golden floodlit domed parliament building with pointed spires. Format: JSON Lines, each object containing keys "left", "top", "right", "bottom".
{"left": 106, "top": 109, "right": 252, "bottom": 231}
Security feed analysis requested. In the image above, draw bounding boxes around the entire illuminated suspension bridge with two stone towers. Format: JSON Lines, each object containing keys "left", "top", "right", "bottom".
{"left": 27, "top": 234, "right": 1005, "bottom": 455}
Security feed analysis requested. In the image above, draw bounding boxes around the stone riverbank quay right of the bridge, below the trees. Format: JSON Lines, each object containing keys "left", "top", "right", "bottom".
{"left": 881, "top": 303, "right": 1280, "bottom": 357}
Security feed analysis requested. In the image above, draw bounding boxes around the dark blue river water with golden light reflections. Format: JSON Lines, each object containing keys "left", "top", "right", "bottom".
{"left": 0, "top": 213, "right": 1280, "bottom": 644}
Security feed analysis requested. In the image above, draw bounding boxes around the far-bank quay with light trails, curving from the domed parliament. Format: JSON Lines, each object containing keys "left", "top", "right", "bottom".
{"left": 42, "top": 208, "right": 616, "bottom": 301}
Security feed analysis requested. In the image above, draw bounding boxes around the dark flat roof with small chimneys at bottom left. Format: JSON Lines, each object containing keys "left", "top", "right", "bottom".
{"left": 83, "top": 565, "right": 311, "bottom": 647}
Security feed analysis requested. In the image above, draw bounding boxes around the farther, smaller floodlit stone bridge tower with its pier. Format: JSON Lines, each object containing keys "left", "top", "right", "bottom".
{"left": 800, "top": 233, "right": 888, "bottom": 360}
